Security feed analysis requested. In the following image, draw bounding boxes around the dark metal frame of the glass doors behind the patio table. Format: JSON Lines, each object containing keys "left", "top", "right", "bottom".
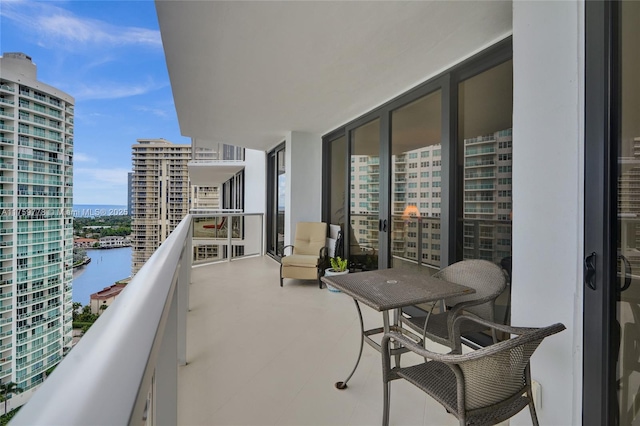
{"left": 322, "top": 37, "right": 513, "bottom": 268}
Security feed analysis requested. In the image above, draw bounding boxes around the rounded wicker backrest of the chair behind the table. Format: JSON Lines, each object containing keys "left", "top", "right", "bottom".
{"left": 434, "top": 259, "right": 507, "bottom": 321}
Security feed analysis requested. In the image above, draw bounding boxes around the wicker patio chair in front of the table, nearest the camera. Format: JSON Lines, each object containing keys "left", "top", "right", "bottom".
{"left": 382, "top": 315, "right": 565, "bottom": 426}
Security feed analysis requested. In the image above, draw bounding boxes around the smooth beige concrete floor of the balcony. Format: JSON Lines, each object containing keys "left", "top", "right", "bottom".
{"left": 178, "top": 257, "right": 458, "bottom": 425}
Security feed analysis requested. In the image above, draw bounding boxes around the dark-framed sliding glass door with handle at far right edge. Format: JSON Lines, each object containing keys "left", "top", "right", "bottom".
{"left": 583, "top": 1, "right": 640, "bottom": 425}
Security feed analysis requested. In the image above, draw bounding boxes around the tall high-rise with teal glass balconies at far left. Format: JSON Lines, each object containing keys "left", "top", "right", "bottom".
{"left": 0, "top": 53, "right": 74, "bottom": 390}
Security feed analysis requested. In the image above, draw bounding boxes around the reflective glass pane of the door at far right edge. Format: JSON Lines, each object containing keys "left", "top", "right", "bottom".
{"left": 612, "top": 2, "right": 640, "bottom": 425}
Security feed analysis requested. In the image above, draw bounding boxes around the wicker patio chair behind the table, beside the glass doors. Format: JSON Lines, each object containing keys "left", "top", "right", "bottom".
{"left": 400, "top": 259, "right": 507, "bottom": 349}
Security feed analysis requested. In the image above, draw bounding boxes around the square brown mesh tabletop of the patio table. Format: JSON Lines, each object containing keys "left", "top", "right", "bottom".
{"left": 322, "top": 268, "right": 475, "bottom": 311}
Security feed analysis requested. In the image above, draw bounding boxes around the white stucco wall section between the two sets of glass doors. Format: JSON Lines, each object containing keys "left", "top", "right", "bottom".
{"left": 511, "top": 1, "right": 584, "bottom": 425}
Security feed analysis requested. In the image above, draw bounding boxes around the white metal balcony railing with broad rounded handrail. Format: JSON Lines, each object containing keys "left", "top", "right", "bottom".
{"left": 12, "top": 213, "right": 263, "bottom": 425}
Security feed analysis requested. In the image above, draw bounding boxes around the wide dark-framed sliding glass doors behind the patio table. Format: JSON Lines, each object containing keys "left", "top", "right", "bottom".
{"left": 323, "top": 39, "right": 513, "bottom": 282}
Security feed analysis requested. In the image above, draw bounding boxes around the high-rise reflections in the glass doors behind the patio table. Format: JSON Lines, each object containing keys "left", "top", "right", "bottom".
{"left": 351, "top": 129, "right": 512, "bottom": 267}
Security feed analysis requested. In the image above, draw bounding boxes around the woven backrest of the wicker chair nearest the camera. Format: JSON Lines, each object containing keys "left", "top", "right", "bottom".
{"left": 456, "top": 323, "right": 565, "bottom": 410}
